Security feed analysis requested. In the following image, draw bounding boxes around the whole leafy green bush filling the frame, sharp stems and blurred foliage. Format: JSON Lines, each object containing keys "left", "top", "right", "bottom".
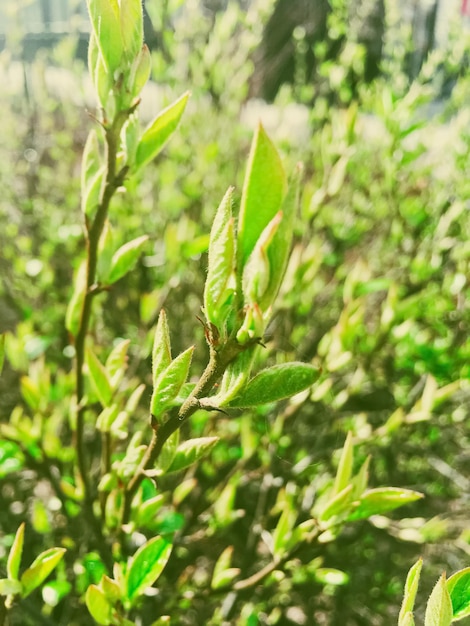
{"left": 0, "top": 0, "right": 470, "bottom": 626}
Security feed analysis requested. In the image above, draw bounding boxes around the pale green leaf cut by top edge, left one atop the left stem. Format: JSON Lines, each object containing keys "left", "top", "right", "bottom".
{"left": 87, "top": 0, "right": 123, "bottom": 75}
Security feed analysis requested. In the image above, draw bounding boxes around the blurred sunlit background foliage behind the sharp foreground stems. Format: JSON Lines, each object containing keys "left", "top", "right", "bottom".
{"left": 0, "top": 0, "right": 470, "bottom": 626}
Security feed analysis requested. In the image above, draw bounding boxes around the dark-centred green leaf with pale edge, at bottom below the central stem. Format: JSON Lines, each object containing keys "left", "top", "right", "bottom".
{"left": 126, "top": 537, "right": 172, "bottom": 603}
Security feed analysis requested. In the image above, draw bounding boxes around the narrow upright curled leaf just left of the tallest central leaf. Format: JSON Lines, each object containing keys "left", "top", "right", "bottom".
{"left": 204, "top": 187, "right": 236, "bottom": 331}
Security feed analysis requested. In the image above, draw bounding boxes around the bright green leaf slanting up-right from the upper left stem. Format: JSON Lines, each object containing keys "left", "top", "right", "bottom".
{"left": 135, "top": 93, "right": 189, "bottom": 169}
